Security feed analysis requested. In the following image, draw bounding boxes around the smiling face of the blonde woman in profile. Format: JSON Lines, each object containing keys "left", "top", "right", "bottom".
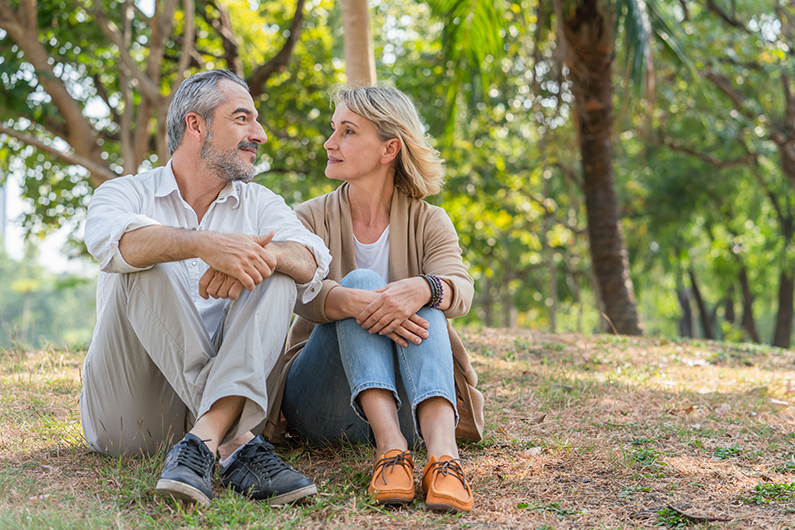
{"left": 323, "top": 103, "right": 394, "bottom": 182}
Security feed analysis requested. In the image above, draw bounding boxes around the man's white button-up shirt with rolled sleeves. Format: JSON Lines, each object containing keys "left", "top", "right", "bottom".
{"left": 85, "top": 161, "right": 331, "bottom": 334}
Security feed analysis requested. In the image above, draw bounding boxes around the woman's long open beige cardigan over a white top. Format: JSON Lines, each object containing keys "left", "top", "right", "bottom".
{"left": 264, "top": 183, "right": 483, "bottom": 441}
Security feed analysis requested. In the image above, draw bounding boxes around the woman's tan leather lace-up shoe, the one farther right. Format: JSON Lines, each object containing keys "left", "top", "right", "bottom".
{"left": 422, "top": 455, "right": 475, "bottom": 512}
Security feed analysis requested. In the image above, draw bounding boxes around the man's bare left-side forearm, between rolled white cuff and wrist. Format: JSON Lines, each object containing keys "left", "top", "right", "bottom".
{"left": 119, "top": 225, "right": 202, "bottom": 269}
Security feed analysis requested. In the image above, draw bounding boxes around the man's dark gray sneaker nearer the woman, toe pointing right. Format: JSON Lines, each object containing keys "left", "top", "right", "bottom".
{"left": 221, "top": 435, "right": 317, "bottom": 505}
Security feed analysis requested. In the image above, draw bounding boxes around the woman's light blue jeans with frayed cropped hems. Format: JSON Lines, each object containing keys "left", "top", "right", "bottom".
{"left": 282, "top": 269, "right": 458, "bottom": 447}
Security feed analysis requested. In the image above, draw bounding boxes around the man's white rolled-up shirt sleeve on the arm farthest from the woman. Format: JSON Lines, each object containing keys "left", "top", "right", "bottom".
{"left": 85, "top": 177, "right": 161, "bottom": 273}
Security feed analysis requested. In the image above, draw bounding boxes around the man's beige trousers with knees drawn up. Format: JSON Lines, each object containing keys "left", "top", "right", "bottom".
{"left": 80, "top": 263, "right": 296, "bottom": 456}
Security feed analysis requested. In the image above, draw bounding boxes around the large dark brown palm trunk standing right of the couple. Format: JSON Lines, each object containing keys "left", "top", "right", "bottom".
{"left": 562, "top": 0, "right": 643, "bottom": 335}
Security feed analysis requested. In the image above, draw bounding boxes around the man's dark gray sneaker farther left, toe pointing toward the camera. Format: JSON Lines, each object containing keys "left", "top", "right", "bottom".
{"left": 155, "top": 433, "right": 215, "bottom": 505}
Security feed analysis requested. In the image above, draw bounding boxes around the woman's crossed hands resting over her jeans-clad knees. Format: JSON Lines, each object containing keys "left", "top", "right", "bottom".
{"left": 356, "top": 277, "right": 431, "bottom": 334}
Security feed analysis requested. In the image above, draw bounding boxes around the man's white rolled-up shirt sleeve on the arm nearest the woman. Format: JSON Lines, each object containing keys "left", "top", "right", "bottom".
{"left": 260, "top": 190, "right": 331, "bottom": 304}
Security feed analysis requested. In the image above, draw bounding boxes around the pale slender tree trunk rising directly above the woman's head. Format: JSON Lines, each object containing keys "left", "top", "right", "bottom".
{"left": 341, "top": 0, "right": 376, "bottom": 86}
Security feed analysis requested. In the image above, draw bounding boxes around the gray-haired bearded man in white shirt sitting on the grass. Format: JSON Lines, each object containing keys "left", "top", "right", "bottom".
{"left": 81, "top": 70, "right": 331, "bottom": 504}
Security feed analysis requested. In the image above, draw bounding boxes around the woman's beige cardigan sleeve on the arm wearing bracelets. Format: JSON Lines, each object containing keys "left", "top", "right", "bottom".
{"left": 422, "top": 208, "right": 475, "bottom": 318}
